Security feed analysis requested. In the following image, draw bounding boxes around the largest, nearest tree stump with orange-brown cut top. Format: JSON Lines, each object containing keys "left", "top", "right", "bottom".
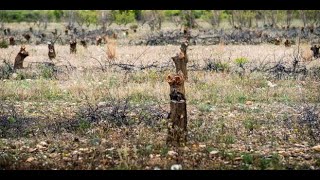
{"left": 167, "top": 71, "right": 187, "bottom": 145}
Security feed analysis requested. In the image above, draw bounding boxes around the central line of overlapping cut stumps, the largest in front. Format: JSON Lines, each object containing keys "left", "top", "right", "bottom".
{"left": 167, "top": 30, "right": 190, "bottom": 146}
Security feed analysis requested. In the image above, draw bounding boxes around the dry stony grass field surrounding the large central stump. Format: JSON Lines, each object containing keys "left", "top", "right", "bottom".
{"left": 0, "top": 41, "right": 320, "bottom": 169}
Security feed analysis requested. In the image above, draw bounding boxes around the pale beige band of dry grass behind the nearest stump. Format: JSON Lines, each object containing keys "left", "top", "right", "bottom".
{"left": 0, "top": 41, "right": 318, "bottom": 68}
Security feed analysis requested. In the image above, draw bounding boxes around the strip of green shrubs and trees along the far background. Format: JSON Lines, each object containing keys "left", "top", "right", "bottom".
{"left": 0, "top": 10, "right": 320, "bottom": 30}
